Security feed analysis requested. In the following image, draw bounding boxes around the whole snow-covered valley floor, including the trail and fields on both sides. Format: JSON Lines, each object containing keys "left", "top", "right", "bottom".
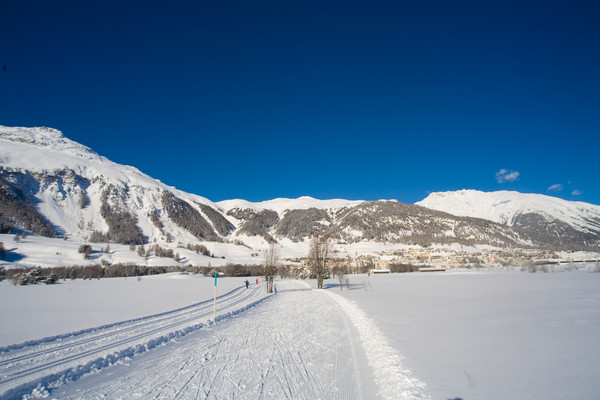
{"left": 0, "top": 271, "right": 600, "bottom": 400}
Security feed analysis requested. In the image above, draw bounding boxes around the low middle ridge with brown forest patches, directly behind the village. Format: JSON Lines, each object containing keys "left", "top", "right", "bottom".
{"left": 218, "top": 197, "right": 534, "bottom": 247}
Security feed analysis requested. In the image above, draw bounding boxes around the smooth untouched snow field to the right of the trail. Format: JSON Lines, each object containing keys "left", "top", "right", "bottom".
{"left": 344, "top": 265, "right": 600, "bottom": 400}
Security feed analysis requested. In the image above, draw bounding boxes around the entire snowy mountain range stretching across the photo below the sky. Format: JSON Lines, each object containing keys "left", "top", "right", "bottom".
{"left": 0, "top": 126, "right": 600, "bottom": 263}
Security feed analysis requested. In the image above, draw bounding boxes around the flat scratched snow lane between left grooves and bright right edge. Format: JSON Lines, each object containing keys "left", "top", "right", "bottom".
{"left": 51, "top": 281, "right": 386, "bottom": 399}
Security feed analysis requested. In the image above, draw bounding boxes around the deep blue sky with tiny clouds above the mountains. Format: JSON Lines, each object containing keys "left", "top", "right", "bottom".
{"left": 0, "top": 0, "right": 600, "bottom": 204}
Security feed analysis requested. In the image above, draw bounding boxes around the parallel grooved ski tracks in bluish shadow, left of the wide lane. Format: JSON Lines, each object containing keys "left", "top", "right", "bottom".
{"left": 0, "top": 285, "right": 266, "bottom": 398}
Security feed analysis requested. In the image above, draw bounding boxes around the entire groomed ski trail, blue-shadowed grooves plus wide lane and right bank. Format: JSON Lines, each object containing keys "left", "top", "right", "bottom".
{"left": 0, "top": 280, "right": 429, "bottom": 399}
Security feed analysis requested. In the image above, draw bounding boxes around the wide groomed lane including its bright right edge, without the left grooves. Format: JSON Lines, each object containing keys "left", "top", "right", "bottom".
{"left": 5, "top": 280, "right": 429, "bottom": 400}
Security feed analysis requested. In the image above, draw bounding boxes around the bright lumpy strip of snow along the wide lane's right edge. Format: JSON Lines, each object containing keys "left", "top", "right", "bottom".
{"left": 324, "top": 290, "right": 431, "bottom": 400}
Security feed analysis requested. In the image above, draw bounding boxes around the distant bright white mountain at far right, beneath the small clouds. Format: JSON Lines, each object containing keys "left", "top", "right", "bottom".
{"left": 416, "top": 190, "right": 600, "bottom": 248}
